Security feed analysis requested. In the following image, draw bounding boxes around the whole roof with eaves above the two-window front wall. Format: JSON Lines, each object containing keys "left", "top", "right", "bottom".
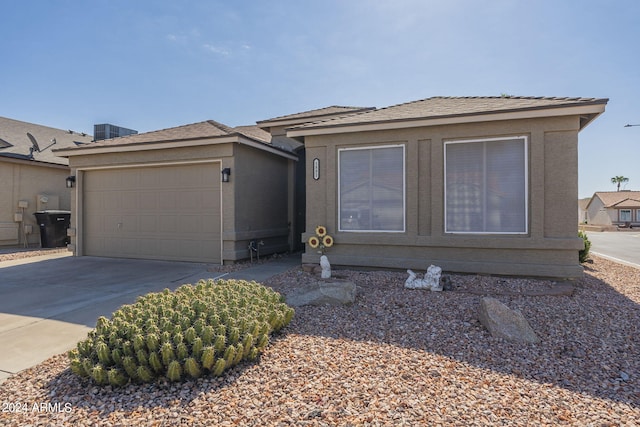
{"left": 288, "top": 96, "right": 609, "bottom": 136}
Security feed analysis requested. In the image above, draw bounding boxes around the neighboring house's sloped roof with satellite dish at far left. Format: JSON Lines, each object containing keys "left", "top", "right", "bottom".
{"left": 0, "top": 117, "right": 93, "bottom": 166}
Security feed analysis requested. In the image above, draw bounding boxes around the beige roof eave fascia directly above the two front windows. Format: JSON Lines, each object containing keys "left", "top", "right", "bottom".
{"left": 287, "top": 100, "right": 606, "bottom": 138}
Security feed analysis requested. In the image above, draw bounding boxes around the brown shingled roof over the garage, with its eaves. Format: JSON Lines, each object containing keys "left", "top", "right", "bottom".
{"left": 54, "top": 120, "right": 296, "bottom": 160}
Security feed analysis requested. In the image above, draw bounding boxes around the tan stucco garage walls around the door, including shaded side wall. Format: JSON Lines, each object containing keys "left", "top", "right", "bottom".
{"left": 67, "top": 143, "right": 288, "bottom": 262}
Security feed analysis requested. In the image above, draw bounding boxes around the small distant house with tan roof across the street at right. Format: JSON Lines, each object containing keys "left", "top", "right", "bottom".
{"left": 586, "top": 190, "right": 640, "bottom": 227}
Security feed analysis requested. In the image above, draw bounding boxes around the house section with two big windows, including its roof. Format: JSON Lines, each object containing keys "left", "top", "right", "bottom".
{"left": 286, "top": 96, "right": 608, "bottom": 278}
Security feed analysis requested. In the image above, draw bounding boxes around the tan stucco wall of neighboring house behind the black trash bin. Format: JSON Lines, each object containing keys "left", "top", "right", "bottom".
{"left": 0, "top": 159, "right": 71, "bottom": 247}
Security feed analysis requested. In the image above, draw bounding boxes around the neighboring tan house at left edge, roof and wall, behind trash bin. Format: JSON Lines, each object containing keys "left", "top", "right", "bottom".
{"left": 0, "top": 117, "right": 91, "bottom": 247}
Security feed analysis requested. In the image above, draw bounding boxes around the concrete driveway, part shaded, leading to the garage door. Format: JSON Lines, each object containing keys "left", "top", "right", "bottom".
{"left": 0, "top": 254, "right": 229, "bottom": 383}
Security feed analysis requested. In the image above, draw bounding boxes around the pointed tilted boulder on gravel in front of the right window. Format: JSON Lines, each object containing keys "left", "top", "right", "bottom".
{"left": 478, "top": 297, "right": 540, "bottom": 343}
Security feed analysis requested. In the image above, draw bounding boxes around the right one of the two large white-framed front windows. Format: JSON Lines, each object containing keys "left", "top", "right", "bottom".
{"left": 444, "top": 136, "right": 528, "bottom": 234}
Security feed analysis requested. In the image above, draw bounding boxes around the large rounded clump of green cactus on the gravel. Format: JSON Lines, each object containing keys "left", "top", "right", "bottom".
{"left": 68, "top": 280, "right": 294, "bottom": 386}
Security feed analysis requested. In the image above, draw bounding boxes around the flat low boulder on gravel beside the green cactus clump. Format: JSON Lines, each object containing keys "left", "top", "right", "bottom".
{"left": 286, "top": 280, "right": 356, "bottom": 307}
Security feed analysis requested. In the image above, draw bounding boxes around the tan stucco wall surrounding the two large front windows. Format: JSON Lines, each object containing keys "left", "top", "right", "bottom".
{"left": 303, "top": 117, "right": 583, "bottom": 277}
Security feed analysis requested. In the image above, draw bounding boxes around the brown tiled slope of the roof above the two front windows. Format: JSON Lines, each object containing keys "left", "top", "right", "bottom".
{"left": 296, "top": 96, "right": 608, "bottom": 129}
